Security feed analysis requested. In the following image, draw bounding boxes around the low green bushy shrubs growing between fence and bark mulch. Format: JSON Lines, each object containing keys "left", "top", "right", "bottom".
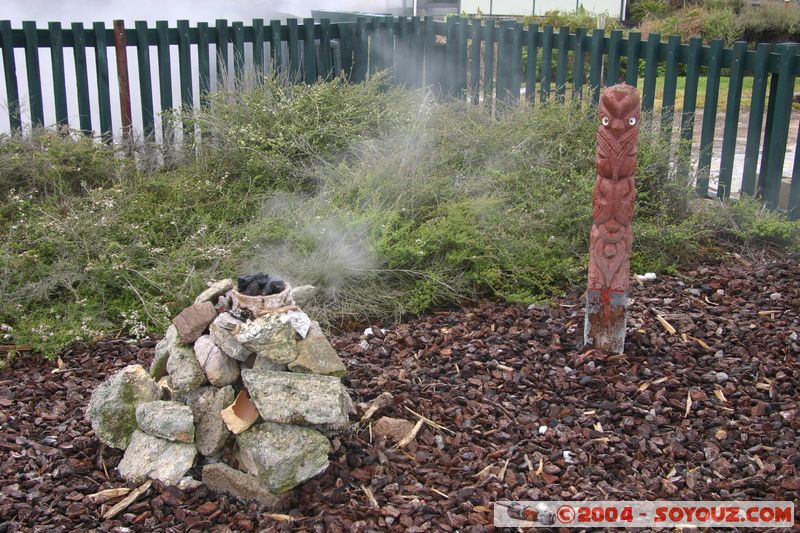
{"left": 0, "top": 76, "right": 798, "bottom": 355}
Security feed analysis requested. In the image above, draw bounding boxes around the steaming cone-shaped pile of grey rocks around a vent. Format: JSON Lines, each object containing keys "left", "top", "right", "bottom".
{"left": 86, "top": 274, "right": 353, "bottom": 506}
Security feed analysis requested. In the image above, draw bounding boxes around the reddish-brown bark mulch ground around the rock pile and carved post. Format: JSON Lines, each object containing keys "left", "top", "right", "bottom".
{"left": 0, "top": 260, "right": 800, "bottom": 532}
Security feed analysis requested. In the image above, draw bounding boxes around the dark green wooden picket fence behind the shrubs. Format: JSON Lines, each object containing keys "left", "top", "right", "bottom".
{"left": 0, "top": 17, "right": 800, "bottom": 217}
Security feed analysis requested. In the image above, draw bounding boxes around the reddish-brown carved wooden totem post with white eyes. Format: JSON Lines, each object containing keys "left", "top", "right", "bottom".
{"left": 584, "top": 85, "right": 641, "bottom": 354}
